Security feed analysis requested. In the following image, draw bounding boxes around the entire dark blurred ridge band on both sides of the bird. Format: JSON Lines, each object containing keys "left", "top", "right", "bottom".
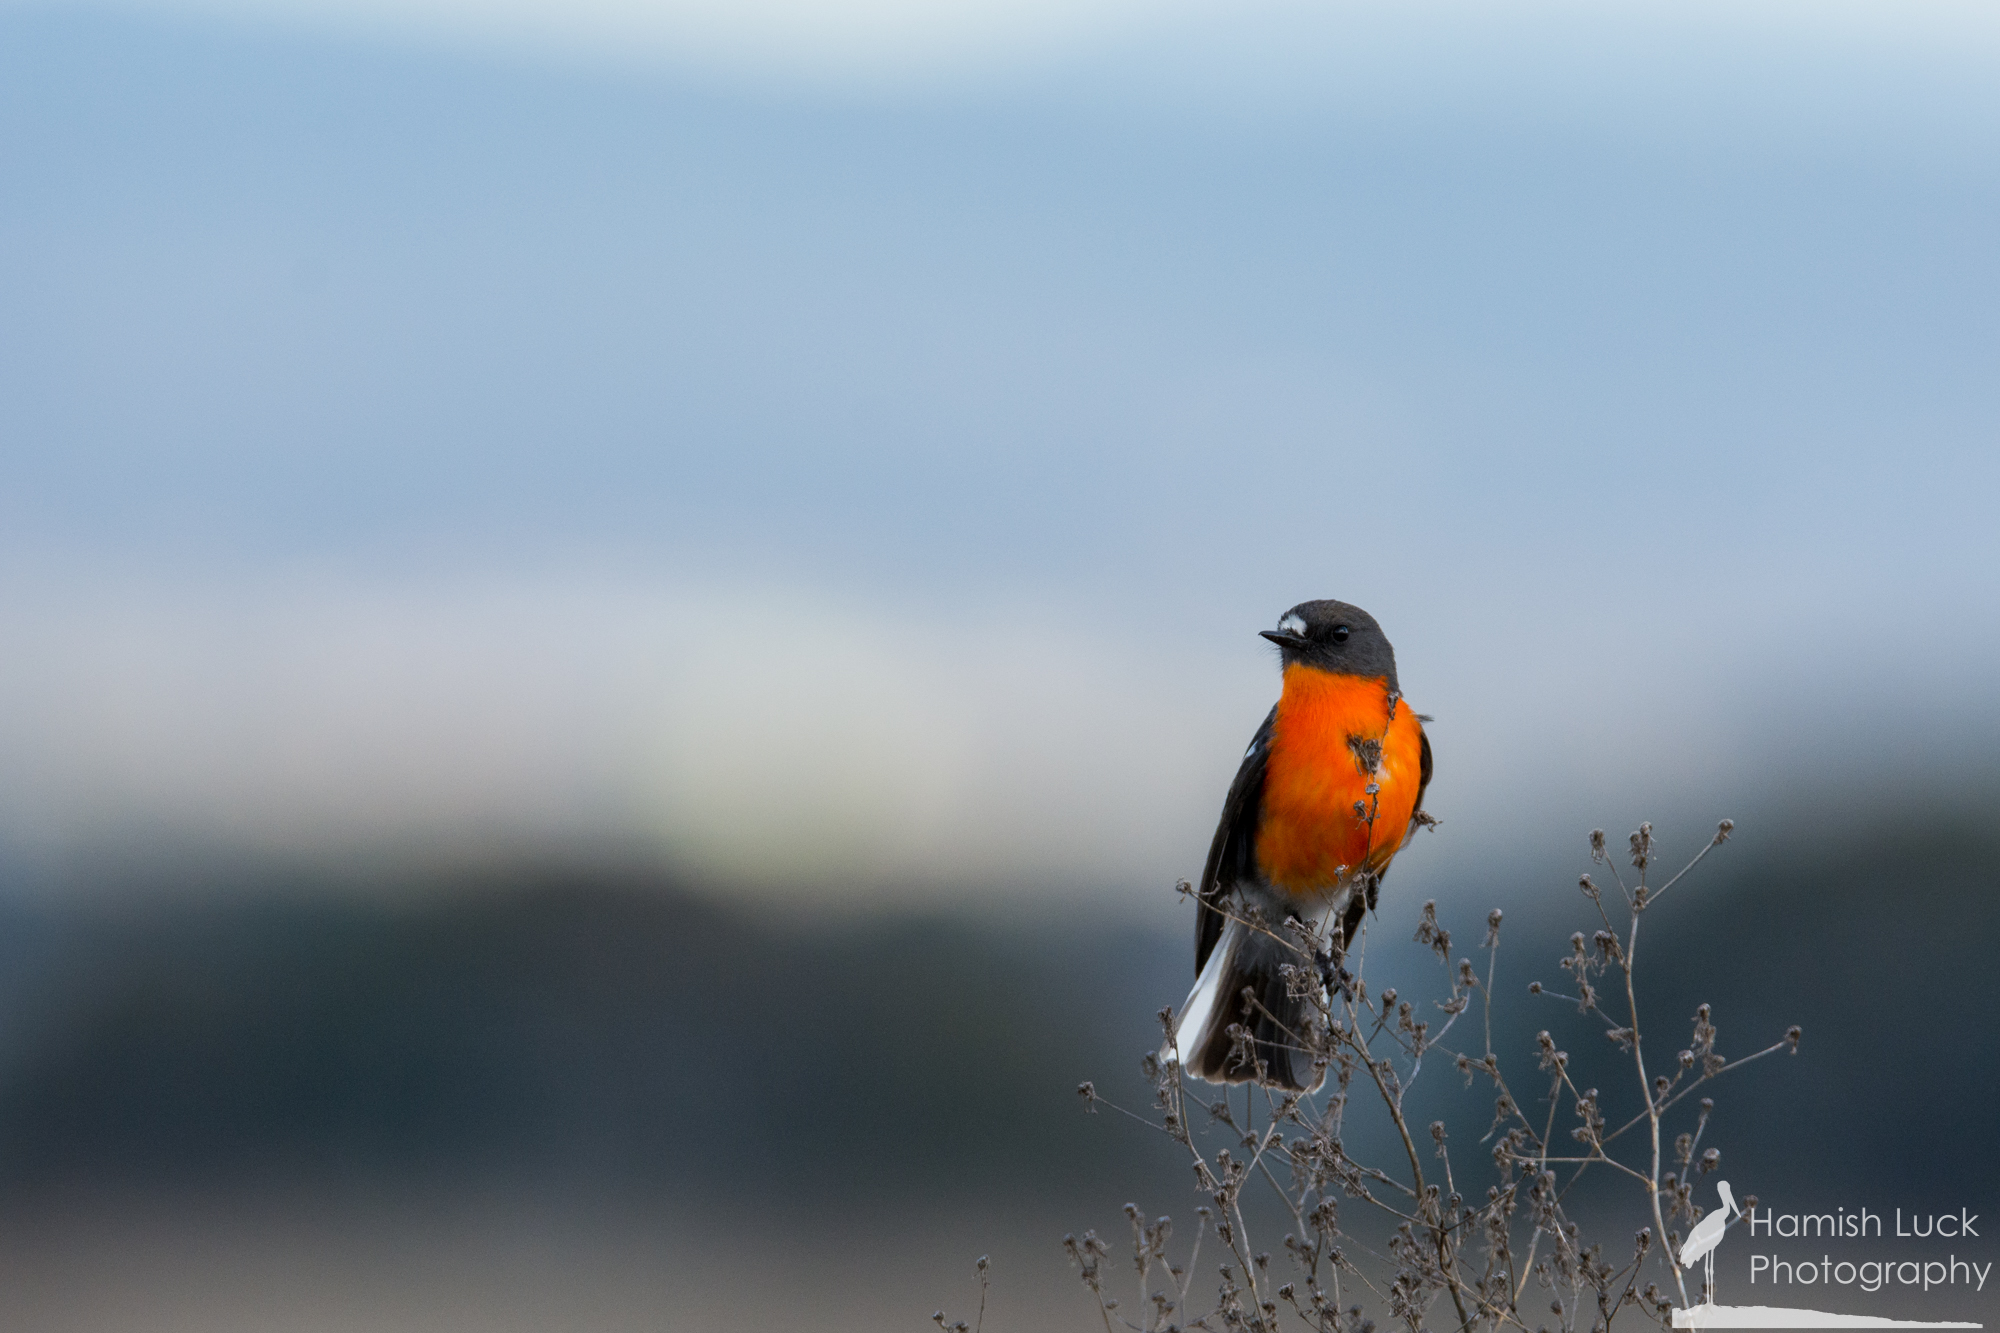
{"left": 0, "top": 792, "right": 2000, "bottom": 1221}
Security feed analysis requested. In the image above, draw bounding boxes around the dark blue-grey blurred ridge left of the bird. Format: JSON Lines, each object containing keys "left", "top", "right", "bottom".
{"left": 0, "top": 871, "right": 1182, "bottom": 1197}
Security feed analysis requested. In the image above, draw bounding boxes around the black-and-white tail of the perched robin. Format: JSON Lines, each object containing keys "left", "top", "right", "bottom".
{"left": 1160, "top": 919, "right": 1326, "bottom": 1091}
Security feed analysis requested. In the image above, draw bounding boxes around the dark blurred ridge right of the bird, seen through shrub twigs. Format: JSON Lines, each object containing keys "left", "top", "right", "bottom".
{"left": 1358, "top": 789, "right": 2000, "bottom": 1211}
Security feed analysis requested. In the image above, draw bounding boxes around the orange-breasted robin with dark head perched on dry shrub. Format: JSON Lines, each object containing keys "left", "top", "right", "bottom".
{"left": 1166, "top": 600, "right": 1430, "bottom": 1089}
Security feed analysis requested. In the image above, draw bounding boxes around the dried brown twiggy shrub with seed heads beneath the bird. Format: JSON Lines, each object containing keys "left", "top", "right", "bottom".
{"left": 1064, "top": 821, "right": 1800, "bottom": 1333}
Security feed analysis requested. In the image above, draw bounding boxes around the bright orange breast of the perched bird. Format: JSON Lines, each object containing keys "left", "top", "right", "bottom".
{"left": 1256, "top": 662, "right": 1424, "bottom": 897}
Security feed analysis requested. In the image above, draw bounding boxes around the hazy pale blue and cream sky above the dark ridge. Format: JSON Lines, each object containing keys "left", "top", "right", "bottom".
{"left": 0, "top": 0, "right": 2000, "bottom": 901}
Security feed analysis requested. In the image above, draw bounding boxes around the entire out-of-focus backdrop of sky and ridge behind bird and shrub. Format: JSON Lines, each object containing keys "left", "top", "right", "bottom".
{"left": 0, "top": 0, "right": 2000, "bottom": 1331}
